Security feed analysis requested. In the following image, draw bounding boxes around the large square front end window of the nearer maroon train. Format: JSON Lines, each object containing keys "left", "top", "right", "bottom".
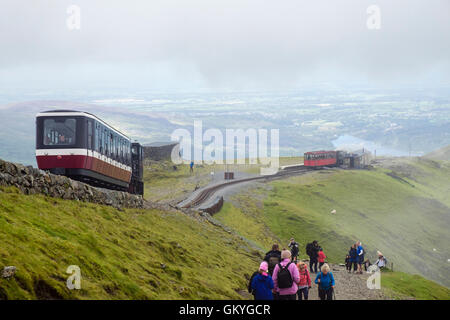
{"left": 43, "top": 117, "right": 77, "bottom": 146}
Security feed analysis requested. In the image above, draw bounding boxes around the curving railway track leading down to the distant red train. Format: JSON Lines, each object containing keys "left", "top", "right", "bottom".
{"left": 178, "top": 166, "right": 311, "bottom": 209}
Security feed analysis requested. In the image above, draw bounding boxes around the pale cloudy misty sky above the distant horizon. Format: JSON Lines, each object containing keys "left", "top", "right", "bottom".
{"left": 0, "top": 0, "right": 450, "bottom": 90}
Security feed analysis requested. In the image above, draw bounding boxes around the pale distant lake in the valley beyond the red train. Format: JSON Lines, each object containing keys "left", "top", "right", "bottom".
{"left": 331, "top": 135, "right": 418, "bottom": 157}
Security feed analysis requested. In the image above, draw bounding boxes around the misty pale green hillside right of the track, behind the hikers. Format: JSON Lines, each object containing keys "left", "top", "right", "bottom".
{"left": 217, "top": 160, "right": 450, "bottom": 298}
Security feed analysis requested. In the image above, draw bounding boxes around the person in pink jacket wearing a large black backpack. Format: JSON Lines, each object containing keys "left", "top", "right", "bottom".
{"left": 272, "top": 250, "right": 300, "bottom": 300}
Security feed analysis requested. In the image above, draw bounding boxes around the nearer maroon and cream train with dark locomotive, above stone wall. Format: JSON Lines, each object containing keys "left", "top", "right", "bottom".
{"left": 36, "top": 110, "right": 144, "bottom": 195}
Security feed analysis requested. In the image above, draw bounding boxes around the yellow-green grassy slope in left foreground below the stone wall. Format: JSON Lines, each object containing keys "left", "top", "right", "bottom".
{"left": 0, "top": 188, "right": 258, "bottom": 299}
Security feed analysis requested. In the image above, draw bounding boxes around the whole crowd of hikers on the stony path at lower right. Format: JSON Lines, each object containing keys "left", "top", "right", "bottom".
{"left": 248, "top": 238, "right": 387, "bottom": 300}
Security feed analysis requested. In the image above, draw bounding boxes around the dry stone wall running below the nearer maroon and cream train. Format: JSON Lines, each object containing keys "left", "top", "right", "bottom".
{"left": 0, "top": 159, "right": 144, "bottom": 209}
